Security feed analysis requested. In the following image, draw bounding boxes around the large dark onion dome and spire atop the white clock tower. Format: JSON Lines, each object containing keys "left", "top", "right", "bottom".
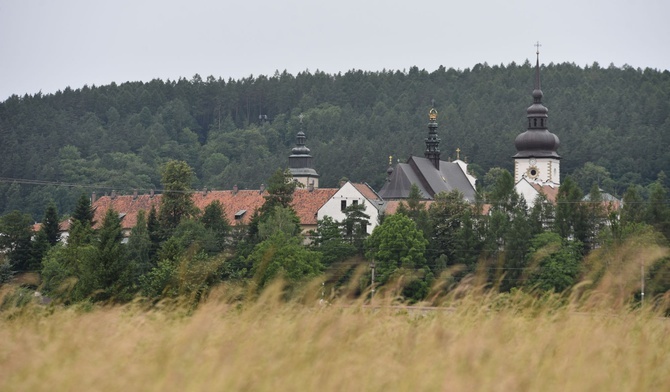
{"left": 514, "top": 53, "right": 561, "bottom": 159}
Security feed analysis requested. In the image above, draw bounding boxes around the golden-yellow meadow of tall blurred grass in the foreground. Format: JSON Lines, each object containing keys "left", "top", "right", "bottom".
{"left": 0, "top": 282, "right": 670, "bottom": 391}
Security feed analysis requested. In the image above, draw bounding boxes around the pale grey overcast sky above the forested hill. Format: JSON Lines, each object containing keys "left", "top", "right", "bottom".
{"left": 0, "top": 0, "right": 670, "bottom": 101}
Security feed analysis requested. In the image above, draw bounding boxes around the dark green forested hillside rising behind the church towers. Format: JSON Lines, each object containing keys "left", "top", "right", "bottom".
{"left": 0, "top": 62, "right": 670, "bottom": 219}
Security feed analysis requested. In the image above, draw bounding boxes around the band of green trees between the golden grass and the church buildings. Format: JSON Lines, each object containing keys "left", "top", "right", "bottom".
{"left": 0, "top": 161, "right": 670, "bottom": 303}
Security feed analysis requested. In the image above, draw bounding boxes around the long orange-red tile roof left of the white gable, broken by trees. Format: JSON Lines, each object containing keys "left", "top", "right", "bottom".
{"left": 93, "top": 188, "right": 337, "bottom": 229}
